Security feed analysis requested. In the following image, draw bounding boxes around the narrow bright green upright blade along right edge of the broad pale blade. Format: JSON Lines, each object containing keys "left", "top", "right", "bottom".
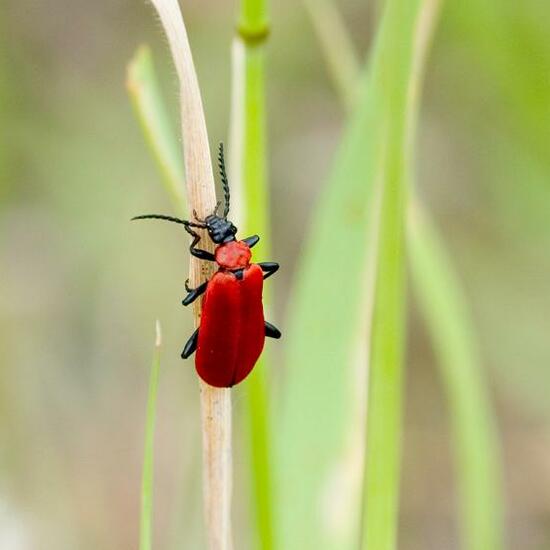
{"left": 361, "top": 0, "right": 429, "bottom": 550}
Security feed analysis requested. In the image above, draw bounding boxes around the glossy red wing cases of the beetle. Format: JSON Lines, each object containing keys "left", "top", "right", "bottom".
{"left": 195, "top": 264, "right": 265, "bottom": 387}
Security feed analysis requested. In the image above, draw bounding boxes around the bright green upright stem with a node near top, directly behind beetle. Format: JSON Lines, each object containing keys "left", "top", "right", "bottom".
{"left": 231, "top": 0, "right": 275, "bottom": 550}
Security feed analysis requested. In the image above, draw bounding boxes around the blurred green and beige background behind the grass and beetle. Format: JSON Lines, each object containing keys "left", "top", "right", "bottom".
{"left": 0, "top": 0, "right": 550, "bottom": 550}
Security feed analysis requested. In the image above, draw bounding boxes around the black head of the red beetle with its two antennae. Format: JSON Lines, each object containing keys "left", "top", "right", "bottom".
{"left": 132, "top": 143, "right": 237, "bottom": 244}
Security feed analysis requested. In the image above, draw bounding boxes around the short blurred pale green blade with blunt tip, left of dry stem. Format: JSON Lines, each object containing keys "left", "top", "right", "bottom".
{"left": 126, "top": 46, "right": 186, "bottom": 215}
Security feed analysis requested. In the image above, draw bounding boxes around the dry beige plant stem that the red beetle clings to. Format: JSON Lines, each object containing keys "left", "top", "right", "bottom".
{"left": 147, "top": 0, "right": 232, "bottom": 550}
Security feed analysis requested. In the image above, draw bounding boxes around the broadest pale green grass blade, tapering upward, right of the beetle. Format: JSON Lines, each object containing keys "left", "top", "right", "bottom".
{"left": 278, "top": 1, "right": 430, "bottom": 549}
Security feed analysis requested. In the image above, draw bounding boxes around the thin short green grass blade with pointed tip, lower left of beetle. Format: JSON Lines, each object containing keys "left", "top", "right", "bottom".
{"left": 139, "top": 321, "right": 161, "bottom": 550}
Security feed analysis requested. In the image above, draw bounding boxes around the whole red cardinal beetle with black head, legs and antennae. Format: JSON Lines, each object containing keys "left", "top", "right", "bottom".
{"left": 132, "top": 143, "right": 281, "bottom": 388}
